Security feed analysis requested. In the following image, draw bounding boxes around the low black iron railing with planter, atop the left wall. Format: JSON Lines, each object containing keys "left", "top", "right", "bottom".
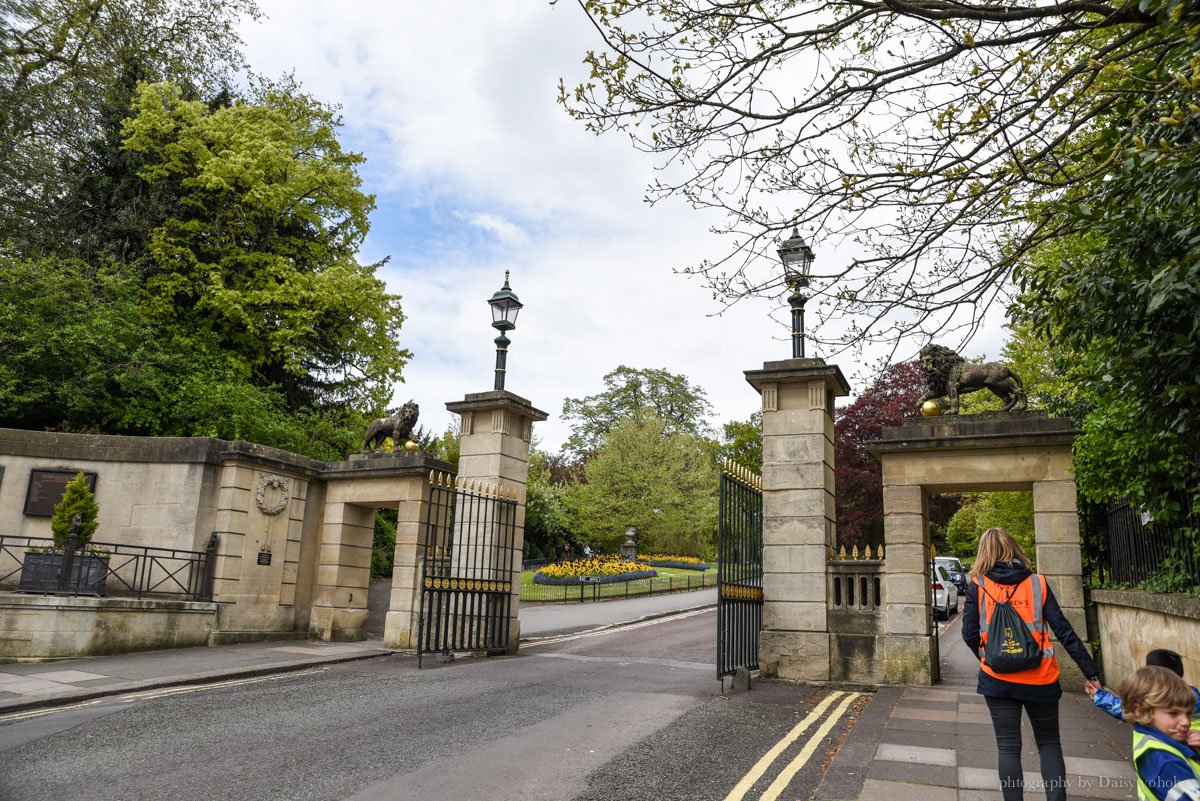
{"left": 0, "top": 532, "right": 217, "bottom": 601}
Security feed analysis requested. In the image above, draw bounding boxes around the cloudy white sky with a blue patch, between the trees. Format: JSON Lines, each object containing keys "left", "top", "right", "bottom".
{"left": 242, "top": 0, "right": 1001, "bottom": 451}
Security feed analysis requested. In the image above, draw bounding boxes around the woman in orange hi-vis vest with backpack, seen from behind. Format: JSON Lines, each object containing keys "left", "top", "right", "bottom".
{"left": 962, "top": 528, "right": 1100, "bottom": 801}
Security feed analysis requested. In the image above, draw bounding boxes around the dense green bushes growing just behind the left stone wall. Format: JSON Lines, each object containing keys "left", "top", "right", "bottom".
{"left": 0, "top": 252, "right": 379, "bottom": 459}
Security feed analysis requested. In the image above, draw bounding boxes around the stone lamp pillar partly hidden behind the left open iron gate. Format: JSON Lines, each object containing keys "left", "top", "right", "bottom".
{"left": 446, "top": 390, "right": 548, "bottom": 654}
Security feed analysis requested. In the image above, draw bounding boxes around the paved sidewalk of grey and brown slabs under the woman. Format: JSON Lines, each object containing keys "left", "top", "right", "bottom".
{"left": 815, "top": 615, "right": 1138, "bottom": 801}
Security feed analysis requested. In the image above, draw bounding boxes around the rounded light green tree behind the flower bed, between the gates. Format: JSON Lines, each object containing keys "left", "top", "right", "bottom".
{"left": 565, "top": 414, "right": 718, "bottom": 558}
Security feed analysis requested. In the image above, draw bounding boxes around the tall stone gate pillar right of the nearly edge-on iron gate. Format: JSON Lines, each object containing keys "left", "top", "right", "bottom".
{"left": 745, "top": 359, "right": 850, "bottom": 681}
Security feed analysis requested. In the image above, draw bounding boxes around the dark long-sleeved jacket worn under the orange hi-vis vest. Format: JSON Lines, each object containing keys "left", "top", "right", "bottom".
{"left": 962, "top": 562, "right": 1100, "bottom": 701}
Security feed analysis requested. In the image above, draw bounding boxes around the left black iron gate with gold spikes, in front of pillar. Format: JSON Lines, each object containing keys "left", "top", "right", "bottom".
{"left": 416, "top": 474, "right": 518, "bottom": 664}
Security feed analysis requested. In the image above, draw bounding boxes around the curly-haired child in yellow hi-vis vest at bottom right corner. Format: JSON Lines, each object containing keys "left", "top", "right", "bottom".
{"left": 1117, "top": 666, "right": 1200, "bottom": 801}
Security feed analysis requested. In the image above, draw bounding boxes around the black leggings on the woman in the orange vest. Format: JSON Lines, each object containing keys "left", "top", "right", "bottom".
{"left": 984, "top": 695, "right": 1067, "bottom": 801}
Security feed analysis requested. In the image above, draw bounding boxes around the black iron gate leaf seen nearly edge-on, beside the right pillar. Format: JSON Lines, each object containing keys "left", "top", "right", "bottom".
{"left": 716, "top": 462, "right": 762, "bottom": 679}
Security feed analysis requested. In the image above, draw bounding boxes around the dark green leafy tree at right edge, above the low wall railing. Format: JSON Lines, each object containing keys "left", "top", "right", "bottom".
{"left": 1018, "top": 188, "right": 1200, "bottom": 523}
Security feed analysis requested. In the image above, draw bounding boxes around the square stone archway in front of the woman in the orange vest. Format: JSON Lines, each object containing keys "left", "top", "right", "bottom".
{"left": 858, "top": 412, "right": 1086, "bottom": 687}
